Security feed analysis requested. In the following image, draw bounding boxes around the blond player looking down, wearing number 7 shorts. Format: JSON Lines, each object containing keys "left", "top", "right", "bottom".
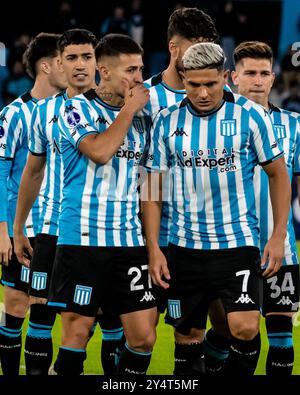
{"left": 144, "top": 43, "right": 290, "bottom": 375}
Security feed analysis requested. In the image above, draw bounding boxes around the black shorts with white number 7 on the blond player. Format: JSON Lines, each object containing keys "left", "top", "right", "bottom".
{"left": 166, "top": 244, "right": 262, "bottom": 328}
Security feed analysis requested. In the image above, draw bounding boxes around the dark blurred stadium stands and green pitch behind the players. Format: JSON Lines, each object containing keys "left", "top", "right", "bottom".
{"left": 0, "top": 0, "right": 300, "bottom": 374}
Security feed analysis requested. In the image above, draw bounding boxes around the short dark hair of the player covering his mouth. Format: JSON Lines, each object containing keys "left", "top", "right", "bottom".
{"left": 95, "top": 33, "right": 144, "bottom": 61}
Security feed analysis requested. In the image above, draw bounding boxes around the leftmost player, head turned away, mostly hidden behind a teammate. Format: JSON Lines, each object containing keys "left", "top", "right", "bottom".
{"left": 0, "top": 33, "right": 65, "bottom": 375}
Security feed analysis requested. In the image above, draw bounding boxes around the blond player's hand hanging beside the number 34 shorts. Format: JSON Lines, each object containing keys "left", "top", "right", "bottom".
{"left": 261, "top": 236, "right": 284, "bottom": 278}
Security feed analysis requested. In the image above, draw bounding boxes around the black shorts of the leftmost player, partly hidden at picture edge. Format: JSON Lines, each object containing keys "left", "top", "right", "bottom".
{"left": 1, "top": 237, "right": 35, "bottom": 294}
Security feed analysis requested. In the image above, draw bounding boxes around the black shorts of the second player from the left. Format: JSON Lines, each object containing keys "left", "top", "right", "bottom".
{"left": 29, "top": 233, "right": 57, "bottom": 299}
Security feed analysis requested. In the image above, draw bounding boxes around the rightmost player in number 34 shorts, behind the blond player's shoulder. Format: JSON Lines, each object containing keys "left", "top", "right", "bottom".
{"left": 232, "top": 41, "right": 300, "bottom": 376}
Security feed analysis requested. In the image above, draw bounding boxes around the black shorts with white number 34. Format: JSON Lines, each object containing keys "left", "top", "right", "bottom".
{"left": 262, "top": 265, "right": 299, "bottom": 316}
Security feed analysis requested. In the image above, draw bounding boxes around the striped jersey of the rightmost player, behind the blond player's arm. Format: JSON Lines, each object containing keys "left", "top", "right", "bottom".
{"left": 237, "top": 96, "right": 300, "bottom": 265}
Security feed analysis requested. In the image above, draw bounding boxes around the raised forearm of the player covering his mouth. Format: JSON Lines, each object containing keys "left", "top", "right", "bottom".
{"left": 94, "top": 105, "right": 134, "bottom": 164}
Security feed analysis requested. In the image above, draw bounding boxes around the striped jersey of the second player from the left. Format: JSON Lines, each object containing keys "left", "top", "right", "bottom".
{"left": 29, "top": 91, "right": 67, "bottom": 236}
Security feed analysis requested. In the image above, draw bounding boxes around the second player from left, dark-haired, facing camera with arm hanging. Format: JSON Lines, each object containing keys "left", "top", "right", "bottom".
{"left": 14, "top": 29, "right": 97, "bottom": 375}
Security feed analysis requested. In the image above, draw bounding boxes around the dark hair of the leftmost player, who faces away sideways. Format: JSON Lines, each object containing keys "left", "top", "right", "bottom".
{"left": 23, "top": 33, "right": 60, "bottom": 79}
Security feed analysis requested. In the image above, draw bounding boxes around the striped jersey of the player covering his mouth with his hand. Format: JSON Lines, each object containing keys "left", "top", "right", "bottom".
{"left": 58, "top": 90, "right": 149, "bottom": 247}
